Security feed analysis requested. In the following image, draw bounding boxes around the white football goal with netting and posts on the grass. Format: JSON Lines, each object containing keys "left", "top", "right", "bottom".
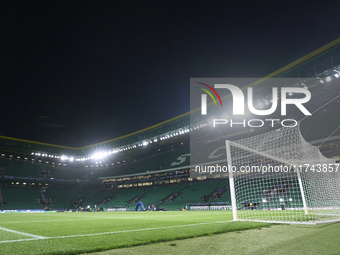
{"left": 226, "top": 125, "right": 340, "bottom": 223}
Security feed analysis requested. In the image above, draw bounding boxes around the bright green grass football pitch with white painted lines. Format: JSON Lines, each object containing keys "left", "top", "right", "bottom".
{"left": 0, "top": 211, "right": 340, "bottom": 254}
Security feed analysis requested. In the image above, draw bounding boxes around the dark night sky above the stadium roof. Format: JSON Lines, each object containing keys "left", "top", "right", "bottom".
{"left": 0, "top": 0, "right": 340, "bottom": 146}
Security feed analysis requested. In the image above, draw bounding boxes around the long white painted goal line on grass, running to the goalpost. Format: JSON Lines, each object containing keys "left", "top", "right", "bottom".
{"left": 0, "top": 220, "right": 233, "bottom": 244}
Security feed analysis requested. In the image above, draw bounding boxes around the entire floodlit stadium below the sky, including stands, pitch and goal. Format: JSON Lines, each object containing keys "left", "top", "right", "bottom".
{"left": 0, "top": 34, "right": 340, "bottom": 254}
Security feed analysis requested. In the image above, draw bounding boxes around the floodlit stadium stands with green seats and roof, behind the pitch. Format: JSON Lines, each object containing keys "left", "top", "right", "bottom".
{"left": 0, "top": 36, "right": 340, "bottom": 210}
